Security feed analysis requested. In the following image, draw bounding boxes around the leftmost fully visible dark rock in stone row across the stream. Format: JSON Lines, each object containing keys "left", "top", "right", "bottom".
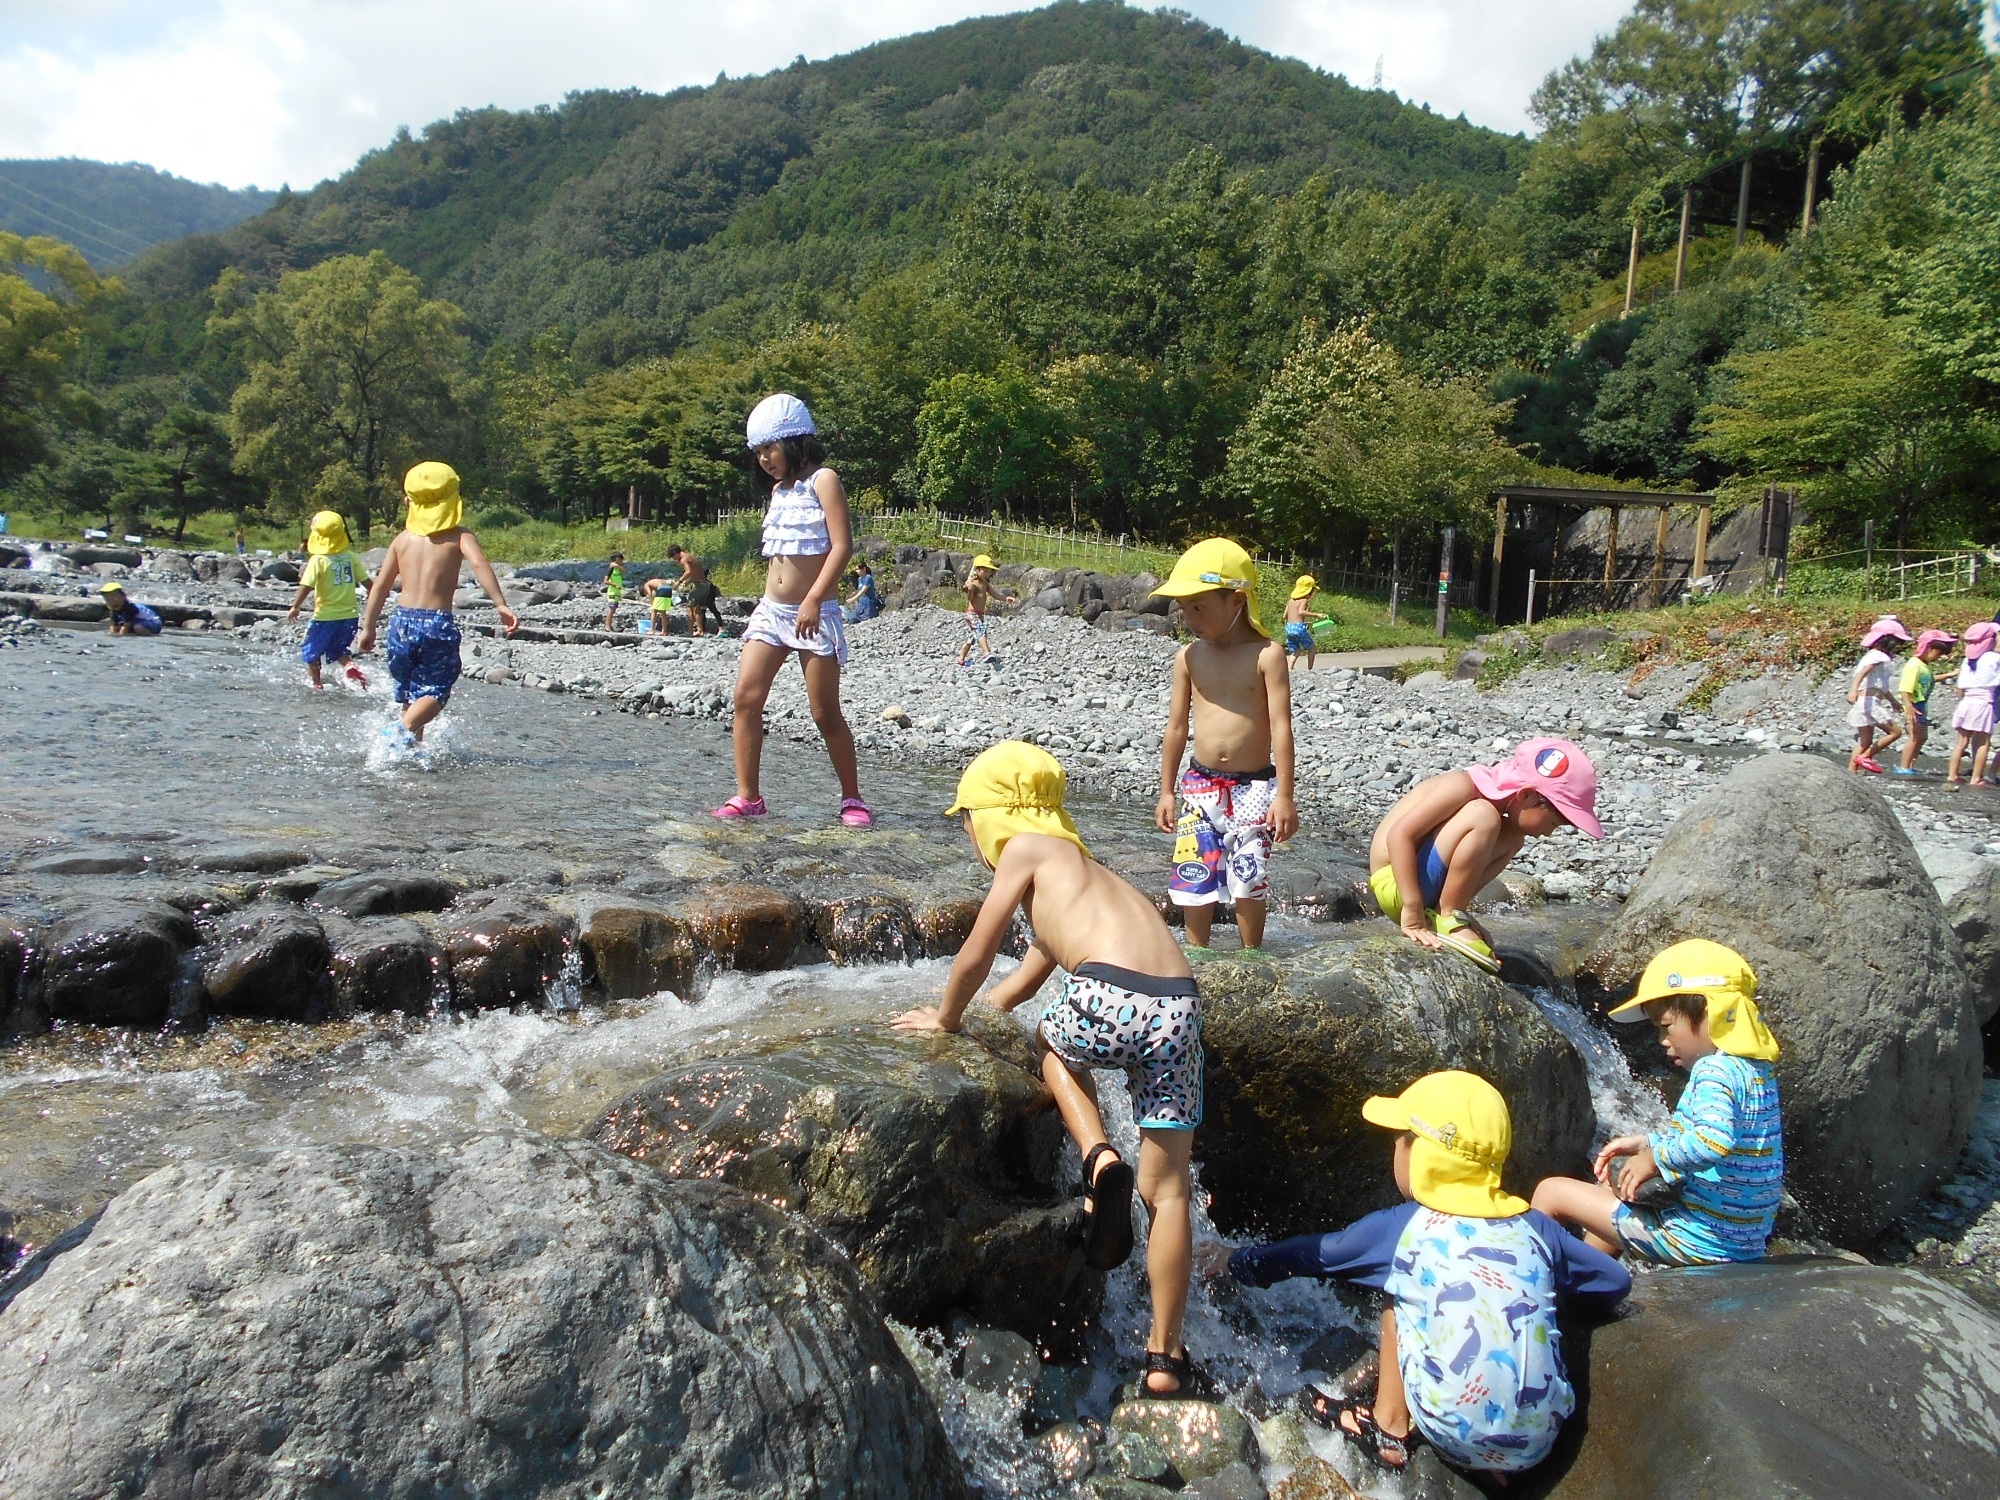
{"left": 44, "top": 904, "right": 196, "bottom": 1026}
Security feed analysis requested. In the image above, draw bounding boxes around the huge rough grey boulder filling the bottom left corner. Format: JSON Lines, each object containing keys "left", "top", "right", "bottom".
{"left": 0, "top": 1134, "right": 964, "bottom": 1500}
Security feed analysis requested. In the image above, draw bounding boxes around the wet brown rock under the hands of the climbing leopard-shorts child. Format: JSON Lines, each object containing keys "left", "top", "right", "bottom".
{"left": 590, "top": 1000, "right": 1102, "bottom": 1340}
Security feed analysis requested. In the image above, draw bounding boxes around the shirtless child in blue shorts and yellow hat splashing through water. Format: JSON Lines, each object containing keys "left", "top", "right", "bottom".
{"left": 356, "top": 462, "right": 520, "bottom": 750}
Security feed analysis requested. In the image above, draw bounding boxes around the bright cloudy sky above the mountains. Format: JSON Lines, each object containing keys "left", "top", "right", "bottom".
{"left": 0, "top": 0, "right": 1630, "bottom": 188}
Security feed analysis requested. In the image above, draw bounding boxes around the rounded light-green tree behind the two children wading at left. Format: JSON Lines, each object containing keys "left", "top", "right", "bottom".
{"left": 210, "top": 250, "right": 466, "bottom": 536}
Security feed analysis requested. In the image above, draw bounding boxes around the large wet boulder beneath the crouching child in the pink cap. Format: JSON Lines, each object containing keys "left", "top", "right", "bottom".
{"left": 1194, "top": 940, "right": 1596, "bottom": 1236}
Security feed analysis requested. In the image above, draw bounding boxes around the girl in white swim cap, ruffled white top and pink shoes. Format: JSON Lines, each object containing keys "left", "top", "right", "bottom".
{"left": 714, "top": 392, "right": 874, "bottom": 828}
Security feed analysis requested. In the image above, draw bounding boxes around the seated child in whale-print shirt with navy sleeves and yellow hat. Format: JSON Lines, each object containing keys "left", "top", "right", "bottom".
{"left": 1228, "top": 1072, "right": 1632, "bottom": 1472}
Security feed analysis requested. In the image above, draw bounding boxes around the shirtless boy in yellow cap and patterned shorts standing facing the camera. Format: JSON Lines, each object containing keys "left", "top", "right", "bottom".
{"left": 1152, "top": 536, "right": 1298, "bottom": 948}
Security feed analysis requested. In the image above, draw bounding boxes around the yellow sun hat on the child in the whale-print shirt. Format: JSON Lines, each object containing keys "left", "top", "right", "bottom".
{"left": 1362, "top": 1068, "right": 1528, "bottom": 1218}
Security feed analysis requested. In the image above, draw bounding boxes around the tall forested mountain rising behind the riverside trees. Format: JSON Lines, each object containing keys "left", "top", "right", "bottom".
{"left": 117, "top": 0, "right": 1526, "bottom": 362}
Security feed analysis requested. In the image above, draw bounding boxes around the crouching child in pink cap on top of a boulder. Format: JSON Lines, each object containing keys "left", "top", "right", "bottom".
{"left": 1368, "top": 740, "right": 1604, "bottom": 972}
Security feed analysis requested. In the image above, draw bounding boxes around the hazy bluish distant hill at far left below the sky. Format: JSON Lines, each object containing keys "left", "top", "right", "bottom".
{"left": 0, "top": 156, "right": 278, "bottom": 270}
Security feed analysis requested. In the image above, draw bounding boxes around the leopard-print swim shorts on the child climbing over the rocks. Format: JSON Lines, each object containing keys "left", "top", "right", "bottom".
{"left": 1042, "top": 964, "right": 1202, "bottom": 1130}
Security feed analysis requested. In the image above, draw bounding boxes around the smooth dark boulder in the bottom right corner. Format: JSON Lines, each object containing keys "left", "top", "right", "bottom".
{"left": 1518, "top": 1260, "right": 2000, "bottom": 1500}
